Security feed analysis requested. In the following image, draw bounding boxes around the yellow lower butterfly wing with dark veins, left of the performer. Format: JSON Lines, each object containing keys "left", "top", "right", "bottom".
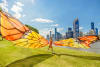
{"left": 13, "top": 31, "right": 48, "bottom": 48}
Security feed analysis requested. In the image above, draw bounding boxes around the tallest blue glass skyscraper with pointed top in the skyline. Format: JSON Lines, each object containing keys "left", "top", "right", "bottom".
{"left": 73, "top": 18, "right": 79, "bottom": 38}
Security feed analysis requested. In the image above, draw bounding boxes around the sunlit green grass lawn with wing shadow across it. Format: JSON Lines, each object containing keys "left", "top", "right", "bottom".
{"left": 0, "top": 37, "right": 100, "bottom": 67}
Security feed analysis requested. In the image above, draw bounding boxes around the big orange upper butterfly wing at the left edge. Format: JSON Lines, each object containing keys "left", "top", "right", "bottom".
{"left": 0, "top": 11, "right": 29, "bottom": 41}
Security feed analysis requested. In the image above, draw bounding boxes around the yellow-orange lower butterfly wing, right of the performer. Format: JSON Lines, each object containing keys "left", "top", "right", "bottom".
{"left": 54, "top": 38, "right": 89, "bottom": 48}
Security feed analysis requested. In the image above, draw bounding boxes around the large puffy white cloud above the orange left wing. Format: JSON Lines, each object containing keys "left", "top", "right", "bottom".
{"left": 11, "top": 2, "right": 24, "bottom": 19}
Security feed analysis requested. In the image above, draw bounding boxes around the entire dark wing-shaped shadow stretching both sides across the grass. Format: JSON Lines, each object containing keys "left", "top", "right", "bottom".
{"left": 6, "top": 53, "right": 100, "bottom": 67}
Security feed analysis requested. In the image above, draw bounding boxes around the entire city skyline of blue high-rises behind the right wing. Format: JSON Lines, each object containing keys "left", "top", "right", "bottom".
{"left": 46, "top": 18, "right": 99, "bottom": 40}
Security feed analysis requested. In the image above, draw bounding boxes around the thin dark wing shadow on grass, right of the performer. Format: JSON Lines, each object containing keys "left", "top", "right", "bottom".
{"left": 55, "top": 53, "right": 100, "bottom": 61}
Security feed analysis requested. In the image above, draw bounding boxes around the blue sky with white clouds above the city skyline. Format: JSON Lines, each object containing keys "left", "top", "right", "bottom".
{"left": 0, "top": 0, "right": 100, "bottom": 35}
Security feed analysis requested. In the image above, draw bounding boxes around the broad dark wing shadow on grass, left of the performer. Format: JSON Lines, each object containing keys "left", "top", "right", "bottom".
{"left": 6, "top": 54, "right": 53, "bottom": 67}
